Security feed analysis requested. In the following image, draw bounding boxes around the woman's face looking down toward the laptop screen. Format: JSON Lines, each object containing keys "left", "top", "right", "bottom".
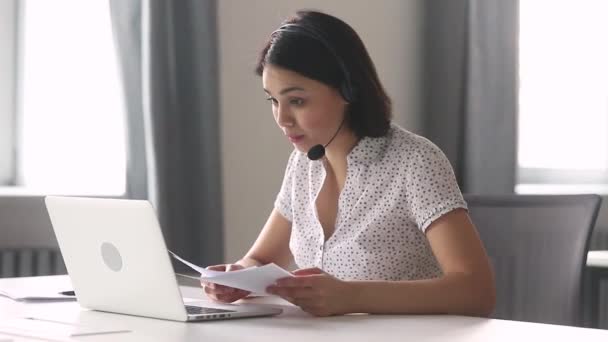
{"left": 262, "top": 65, "right": 348, "bottom": 152}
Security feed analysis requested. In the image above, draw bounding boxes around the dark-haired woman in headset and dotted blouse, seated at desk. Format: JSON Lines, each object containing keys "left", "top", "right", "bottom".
{"left": 202, "top": 11, "right": 495, "bottom": 316}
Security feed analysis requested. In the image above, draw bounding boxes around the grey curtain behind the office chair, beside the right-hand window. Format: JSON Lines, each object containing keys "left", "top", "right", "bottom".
{"left": 423, "top": 0, "right": 518, "bottom": 194}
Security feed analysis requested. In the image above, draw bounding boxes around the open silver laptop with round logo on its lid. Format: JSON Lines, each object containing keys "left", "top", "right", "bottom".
{"left": 45, "top": 196, "right": 282, "bottom": 322}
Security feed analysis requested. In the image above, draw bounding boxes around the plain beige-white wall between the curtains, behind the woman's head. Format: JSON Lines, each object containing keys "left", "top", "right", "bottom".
{"left": 218, "top": 0, "right": 424, "bottom": 261}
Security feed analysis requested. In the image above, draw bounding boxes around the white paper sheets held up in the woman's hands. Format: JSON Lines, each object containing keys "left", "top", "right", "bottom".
{"left": 169, "top": 251, "right": 293, "bottom": 293}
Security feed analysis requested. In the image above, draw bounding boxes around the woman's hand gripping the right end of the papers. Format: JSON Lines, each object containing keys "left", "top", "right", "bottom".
{"left": 267, "top": 267, "right": 353, "bottom": 316}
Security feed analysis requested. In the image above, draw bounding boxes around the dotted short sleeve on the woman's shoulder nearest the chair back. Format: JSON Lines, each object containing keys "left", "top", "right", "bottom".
{"left": 406, "top": 137, "right": 467, "bottom": 232}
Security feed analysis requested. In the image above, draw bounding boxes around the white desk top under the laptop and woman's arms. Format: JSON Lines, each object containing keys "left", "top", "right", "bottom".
{"left": 0, "top": 276, "right": 608, "bottom": 342}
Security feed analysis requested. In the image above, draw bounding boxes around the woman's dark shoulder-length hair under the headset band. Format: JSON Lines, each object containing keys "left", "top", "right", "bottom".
{"left": 255, "top": 11, "right": 391, "bottom": 138}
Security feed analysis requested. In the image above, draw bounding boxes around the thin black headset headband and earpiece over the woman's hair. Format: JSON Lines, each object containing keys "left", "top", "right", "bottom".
{"left": 271, "top": 24, "right": 357, "bottom": 103}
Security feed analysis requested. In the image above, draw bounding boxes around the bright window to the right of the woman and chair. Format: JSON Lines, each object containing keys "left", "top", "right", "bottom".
{"left": 516, "top": 0, "right": 608, "bottom": 193}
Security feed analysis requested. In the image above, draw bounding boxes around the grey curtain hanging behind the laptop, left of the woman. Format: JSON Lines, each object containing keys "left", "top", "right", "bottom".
{"left": 110, "top": 0, "right": 223, "bottom": 264}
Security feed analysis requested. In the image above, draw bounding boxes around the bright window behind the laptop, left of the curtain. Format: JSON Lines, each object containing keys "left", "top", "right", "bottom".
{"left": 4, "top": 0, "right": 126, "bottom": 195}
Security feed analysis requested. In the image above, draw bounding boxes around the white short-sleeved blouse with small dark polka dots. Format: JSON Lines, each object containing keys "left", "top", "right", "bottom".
{"left": 275, "top": 124, "right": 466, "bottom": 280}
